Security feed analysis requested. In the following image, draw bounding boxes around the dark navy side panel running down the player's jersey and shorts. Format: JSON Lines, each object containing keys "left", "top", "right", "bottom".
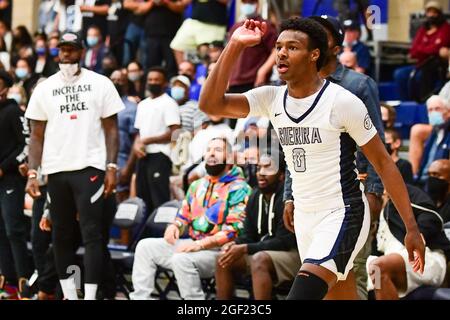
{"left": 303, "top": 133, "right": 365, "bottom": 274}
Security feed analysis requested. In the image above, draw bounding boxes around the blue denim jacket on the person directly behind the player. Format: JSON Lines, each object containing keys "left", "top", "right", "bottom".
{"left": 283, "top": 63, "right": 384, "bottom": 200}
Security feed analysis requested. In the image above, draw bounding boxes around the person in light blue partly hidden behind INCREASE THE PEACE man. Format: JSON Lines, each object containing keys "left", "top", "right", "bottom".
{"left": 110, "top": 70, "right": 137, "bottom": 202}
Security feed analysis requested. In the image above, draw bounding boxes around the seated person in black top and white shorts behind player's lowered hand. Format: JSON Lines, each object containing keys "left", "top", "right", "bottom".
{"left": 366, "top": 185, "right": 450, "bottom": 300}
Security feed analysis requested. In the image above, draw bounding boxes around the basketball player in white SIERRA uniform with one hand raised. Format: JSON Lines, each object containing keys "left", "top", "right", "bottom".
{"left": 200, "top": 18, "right": 425, "bottom": 299}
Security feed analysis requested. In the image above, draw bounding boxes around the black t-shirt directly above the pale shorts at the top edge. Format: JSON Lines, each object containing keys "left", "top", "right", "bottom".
{"left": 192, "top": 0, "right": 227, "bottom": 26}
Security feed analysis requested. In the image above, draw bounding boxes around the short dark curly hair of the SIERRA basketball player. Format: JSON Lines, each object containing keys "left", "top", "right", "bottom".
{"left": 280, "top": 17, "right": 328, "bottom": 70}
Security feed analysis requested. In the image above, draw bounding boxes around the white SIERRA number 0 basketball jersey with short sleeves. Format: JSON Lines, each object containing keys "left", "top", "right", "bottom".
{"left": 245, "top": 80, "right": 377, "bottom": 212}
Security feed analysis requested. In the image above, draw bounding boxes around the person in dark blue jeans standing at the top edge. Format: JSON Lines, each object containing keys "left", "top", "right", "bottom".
{"left": 122, "top": 0, "right": 152, "bottom": 65}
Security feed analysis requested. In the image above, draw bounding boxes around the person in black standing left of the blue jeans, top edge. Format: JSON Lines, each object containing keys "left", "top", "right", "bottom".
{"left": 106, "top": 0, "right": 131, "bottom": 64}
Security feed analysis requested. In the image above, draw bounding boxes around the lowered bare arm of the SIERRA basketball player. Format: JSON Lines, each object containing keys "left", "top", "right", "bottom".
{"left": 361, "top": 135, "right": 425, "bottom": 273}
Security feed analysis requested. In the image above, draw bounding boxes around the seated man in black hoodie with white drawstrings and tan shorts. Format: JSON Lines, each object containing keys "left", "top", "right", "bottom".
{"left": 216, "top": 152, "right": 301, "bottom": 300}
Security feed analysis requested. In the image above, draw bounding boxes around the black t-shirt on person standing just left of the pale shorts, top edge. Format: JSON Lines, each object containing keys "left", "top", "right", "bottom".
{"left": 145, "top": 0, "right": 183, "bottom": 38}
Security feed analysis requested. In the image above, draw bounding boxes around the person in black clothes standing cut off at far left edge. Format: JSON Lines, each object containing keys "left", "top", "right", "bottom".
{"left": 0, "top": 71, "right": 32, "bottom": 298}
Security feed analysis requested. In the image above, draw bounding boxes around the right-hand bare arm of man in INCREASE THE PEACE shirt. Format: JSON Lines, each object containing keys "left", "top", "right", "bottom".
{"left": 101, "top": 114, "right": 119, "bottom": 197}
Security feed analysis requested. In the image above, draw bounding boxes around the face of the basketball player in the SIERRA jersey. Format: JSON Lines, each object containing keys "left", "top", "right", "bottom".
{"left": 275, "top": 30, "right": 318, "bottom": 81}
